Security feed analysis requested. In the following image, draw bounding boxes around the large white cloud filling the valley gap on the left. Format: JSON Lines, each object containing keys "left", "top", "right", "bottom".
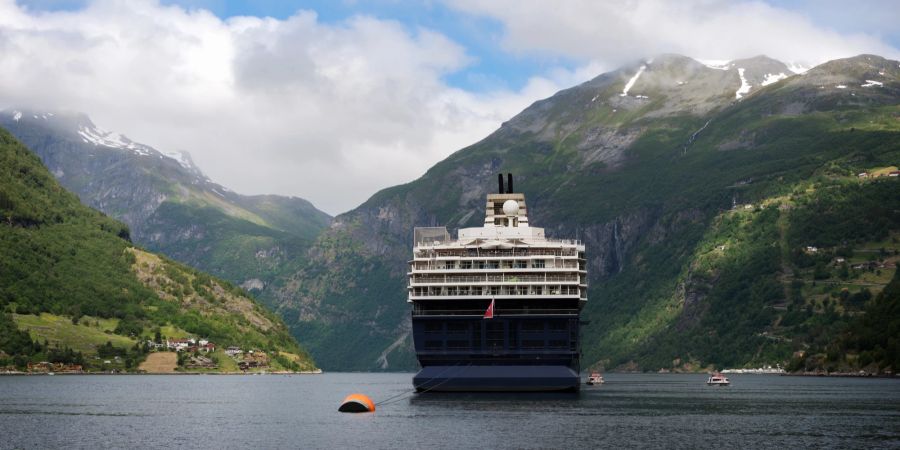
{"left": 0, "top": 0, "right": 570, "bottom": 214}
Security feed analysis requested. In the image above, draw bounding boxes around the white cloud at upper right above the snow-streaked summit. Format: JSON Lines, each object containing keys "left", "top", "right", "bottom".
{"left": 449, "top": 0, "right": 900, "bottom": 65}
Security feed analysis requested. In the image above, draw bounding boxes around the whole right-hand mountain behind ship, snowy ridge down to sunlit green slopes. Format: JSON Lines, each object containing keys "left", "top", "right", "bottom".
{"left": 273, "top": 55, "right": 900, "bottom": 370}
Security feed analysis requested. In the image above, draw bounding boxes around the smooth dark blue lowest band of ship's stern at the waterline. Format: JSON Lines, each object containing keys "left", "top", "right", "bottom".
{"left": 413, "top": 365, "right": 581, "bottom": 392}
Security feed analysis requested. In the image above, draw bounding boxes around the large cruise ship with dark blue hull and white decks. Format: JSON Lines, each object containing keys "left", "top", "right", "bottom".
{"left": 408, "top": 174, "right": 587, "bottom": 392}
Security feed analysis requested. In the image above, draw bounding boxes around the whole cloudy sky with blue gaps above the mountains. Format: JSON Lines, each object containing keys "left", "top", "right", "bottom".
{"left": 0, "top": 0, "right": 900, "bottom": 214}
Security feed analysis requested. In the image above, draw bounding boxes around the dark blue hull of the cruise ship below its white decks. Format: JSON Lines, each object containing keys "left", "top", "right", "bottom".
{"left": 412, "top": 313, "right": 581, "bottom": 392}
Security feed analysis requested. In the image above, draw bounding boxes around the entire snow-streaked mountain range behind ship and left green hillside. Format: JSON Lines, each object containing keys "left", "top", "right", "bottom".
{"left": 0, "top": 55, "right": 900, "bottom": 371}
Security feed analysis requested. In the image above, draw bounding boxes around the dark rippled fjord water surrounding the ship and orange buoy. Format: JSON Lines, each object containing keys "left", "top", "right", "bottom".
{"left": 0, "top": 373, "right": 900, "bottom": 448}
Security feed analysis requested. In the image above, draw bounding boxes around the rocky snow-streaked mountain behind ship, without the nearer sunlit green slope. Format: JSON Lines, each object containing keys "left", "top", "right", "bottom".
{"left": 273, "top": 55, "right": 898, "bottom": 370}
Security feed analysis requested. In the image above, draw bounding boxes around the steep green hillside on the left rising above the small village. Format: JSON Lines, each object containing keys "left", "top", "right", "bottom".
{"left": 0, "top": 125, "right": 314, "bottom": 370}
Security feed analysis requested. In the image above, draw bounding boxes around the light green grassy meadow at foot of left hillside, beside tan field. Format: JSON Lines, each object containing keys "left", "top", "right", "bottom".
{"left": 13, "top": 313, "right": 135, "bottom": 354}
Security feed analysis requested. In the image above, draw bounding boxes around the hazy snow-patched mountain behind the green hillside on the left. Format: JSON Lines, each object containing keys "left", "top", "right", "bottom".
{"left": 0, "top": 108, "right": 331, "bottom": 302}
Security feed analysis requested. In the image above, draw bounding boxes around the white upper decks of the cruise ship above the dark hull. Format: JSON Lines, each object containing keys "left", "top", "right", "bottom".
{"left": 408, "top": 185, "right": 587, "bottom": 307}
